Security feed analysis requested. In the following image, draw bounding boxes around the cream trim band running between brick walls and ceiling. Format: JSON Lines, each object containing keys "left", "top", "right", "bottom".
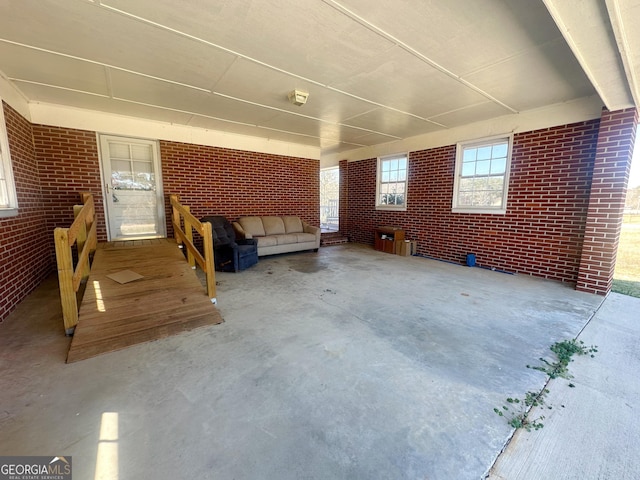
{"left": 0, "top": 92, "right": 603, "bottom": 168}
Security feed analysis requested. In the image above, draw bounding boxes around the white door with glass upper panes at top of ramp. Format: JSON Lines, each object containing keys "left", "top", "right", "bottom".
{"left": 100, "top": 135, "right": 166, "bottom": 240}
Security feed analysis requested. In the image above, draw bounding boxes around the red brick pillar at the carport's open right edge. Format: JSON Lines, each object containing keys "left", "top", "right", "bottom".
{"left": 576, "top": 108, "right": 638, "bottom": 295}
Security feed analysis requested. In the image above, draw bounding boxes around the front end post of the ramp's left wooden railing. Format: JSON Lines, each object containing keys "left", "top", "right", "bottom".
{"left": 53, "top": 227, "right": 78, "bottom": 335}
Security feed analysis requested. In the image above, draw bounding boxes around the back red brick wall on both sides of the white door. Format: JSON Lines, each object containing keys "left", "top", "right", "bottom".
{"left": 26, "top": 125, "right": 319, "bottom": 248}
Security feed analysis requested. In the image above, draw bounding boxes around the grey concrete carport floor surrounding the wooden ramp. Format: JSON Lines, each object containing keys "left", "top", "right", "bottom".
{"left": 0, "top": 244, "right": 640, "bottom": 480}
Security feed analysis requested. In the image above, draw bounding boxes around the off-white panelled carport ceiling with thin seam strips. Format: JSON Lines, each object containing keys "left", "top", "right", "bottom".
{"left": 0, "top": 0, "right": 640, "bottom": 155}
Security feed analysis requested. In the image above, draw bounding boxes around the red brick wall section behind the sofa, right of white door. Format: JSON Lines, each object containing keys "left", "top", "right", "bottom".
{"left": 160, "top": 141, "right": 320, "bottom": 234}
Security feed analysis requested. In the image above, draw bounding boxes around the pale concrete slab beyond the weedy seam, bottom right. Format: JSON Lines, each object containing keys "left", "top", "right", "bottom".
{"left": 488, "top": 293, "right": 640, "bottom": 480}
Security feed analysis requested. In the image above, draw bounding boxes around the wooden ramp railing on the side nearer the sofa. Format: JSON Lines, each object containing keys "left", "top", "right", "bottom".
{"left": 169, "top": 195, "right": 217, "bottom": 303}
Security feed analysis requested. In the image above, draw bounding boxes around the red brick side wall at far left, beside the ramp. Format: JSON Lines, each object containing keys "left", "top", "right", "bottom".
{"left": 0, "top": 103, "right": 53, "bottom": 321}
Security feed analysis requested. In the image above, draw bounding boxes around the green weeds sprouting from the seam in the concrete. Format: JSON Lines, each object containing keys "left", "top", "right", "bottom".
{"left": 493, "top": 340, "right": 598, "bottom": 432}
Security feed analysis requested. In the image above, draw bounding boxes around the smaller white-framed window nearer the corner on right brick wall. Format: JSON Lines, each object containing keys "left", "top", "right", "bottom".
{"left": 376, "top": 153, "right": 409, "bottom": 210}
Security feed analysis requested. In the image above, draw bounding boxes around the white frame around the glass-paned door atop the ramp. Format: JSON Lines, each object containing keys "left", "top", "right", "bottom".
{"left": 96, "top": 132, "right": 167, "bottom": 242}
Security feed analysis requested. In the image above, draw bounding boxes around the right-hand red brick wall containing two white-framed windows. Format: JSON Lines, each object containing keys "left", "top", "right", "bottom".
{"left": 341, "top": 120, "right": 599, "bottom": 282}
